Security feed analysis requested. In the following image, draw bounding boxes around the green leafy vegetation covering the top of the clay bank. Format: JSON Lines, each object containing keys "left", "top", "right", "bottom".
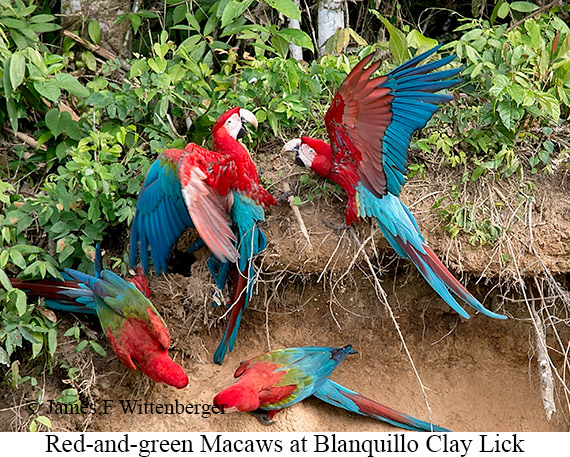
{"left": 0, "top": 0, "right": 570, "bottom": 396}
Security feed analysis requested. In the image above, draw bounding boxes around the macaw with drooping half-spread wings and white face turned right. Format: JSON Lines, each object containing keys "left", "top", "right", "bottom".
{"left": 131, "top": 107, "right": 277, "bottom": 364}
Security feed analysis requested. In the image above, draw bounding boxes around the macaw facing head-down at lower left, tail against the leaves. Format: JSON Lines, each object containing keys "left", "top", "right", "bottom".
{"left": 11, "top": 246, "right": 188, "bottom": 389}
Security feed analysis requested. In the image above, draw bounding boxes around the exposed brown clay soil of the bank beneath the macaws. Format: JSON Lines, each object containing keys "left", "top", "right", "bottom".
{"left": 0, "top": 150, "right": 570, "bottom": 432}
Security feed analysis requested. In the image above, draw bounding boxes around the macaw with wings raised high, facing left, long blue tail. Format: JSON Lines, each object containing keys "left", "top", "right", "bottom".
{"left": 284, "top": 45, "right": 506, "bottom": 319}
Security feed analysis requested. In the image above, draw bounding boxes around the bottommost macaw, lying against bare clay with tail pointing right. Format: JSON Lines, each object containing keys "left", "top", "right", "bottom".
{"left": 214, "top": 346, "right": 449, "bottom": 432}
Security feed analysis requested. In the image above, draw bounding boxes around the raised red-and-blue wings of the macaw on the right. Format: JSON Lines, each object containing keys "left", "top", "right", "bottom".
{"left": 325, "top": 45, "right": 461, "bottom": 198}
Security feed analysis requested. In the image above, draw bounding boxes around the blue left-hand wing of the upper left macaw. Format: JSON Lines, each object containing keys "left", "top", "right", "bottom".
{"left": 130, "top": 149, "right": 194, "bottom": 274}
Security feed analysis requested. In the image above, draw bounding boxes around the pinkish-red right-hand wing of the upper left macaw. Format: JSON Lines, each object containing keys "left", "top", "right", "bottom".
{"left": 178, "top": 144, "right": 239, "bottom": 262}
